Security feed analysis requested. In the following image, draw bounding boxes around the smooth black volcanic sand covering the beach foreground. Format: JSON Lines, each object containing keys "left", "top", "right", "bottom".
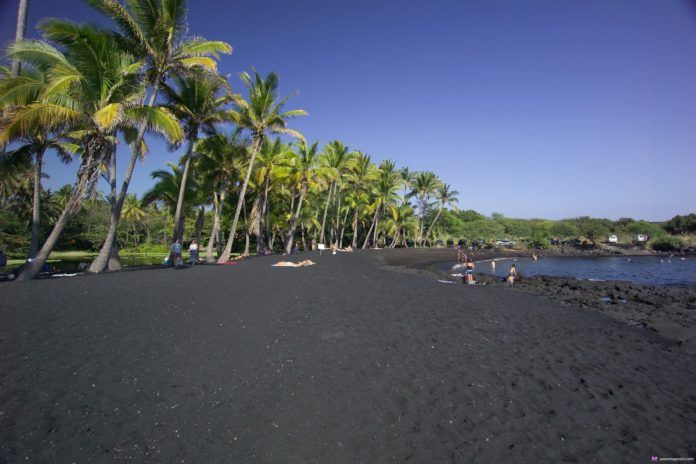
{"left": 0, "top": 250, "right": 696, "bottom": 463}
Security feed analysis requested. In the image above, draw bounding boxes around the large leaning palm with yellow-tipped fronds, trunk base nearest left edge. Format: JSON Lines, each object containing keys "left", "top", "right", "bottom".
{"left": 0, "top": 29, "right": 182, "bottom": 279}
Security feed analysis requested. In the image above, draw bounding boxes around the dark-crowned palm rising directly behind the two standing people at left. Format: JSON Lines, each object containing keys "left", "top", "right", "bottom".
{"left": 162, "top": 70, "right": 229, "bottom": 240}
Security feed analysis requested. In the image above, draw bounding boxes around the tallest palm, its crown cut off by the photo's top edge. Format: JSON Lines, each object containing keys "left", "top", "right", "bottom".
{"left": 85, "top": 0, "right": 232, "bottom": 272}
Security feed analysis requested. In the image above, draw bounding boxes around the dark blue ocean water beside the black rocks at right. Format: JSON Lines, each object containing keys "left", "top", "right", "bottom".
{"left": 440, "top": 256, "right": 696, "bottom": 286}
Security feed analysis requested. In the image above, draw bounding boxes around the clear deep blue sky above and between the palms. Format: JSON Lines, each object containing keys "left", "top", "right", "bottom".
{"left": 0, "top": 0, "right": 696, "bottom": 220}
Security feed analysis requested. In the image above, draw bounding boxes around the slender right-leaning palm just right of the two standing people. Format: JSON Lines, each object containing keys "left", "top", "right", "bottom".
{"left": 218, "top": 71, "right": 307, "bottom": 263}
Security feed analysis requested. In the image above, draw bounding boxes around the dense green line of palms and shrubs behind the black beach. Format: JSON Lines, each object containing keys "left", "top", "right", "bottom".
{"left": 0, "top": 0, "right": 695, "bottom": 279}
